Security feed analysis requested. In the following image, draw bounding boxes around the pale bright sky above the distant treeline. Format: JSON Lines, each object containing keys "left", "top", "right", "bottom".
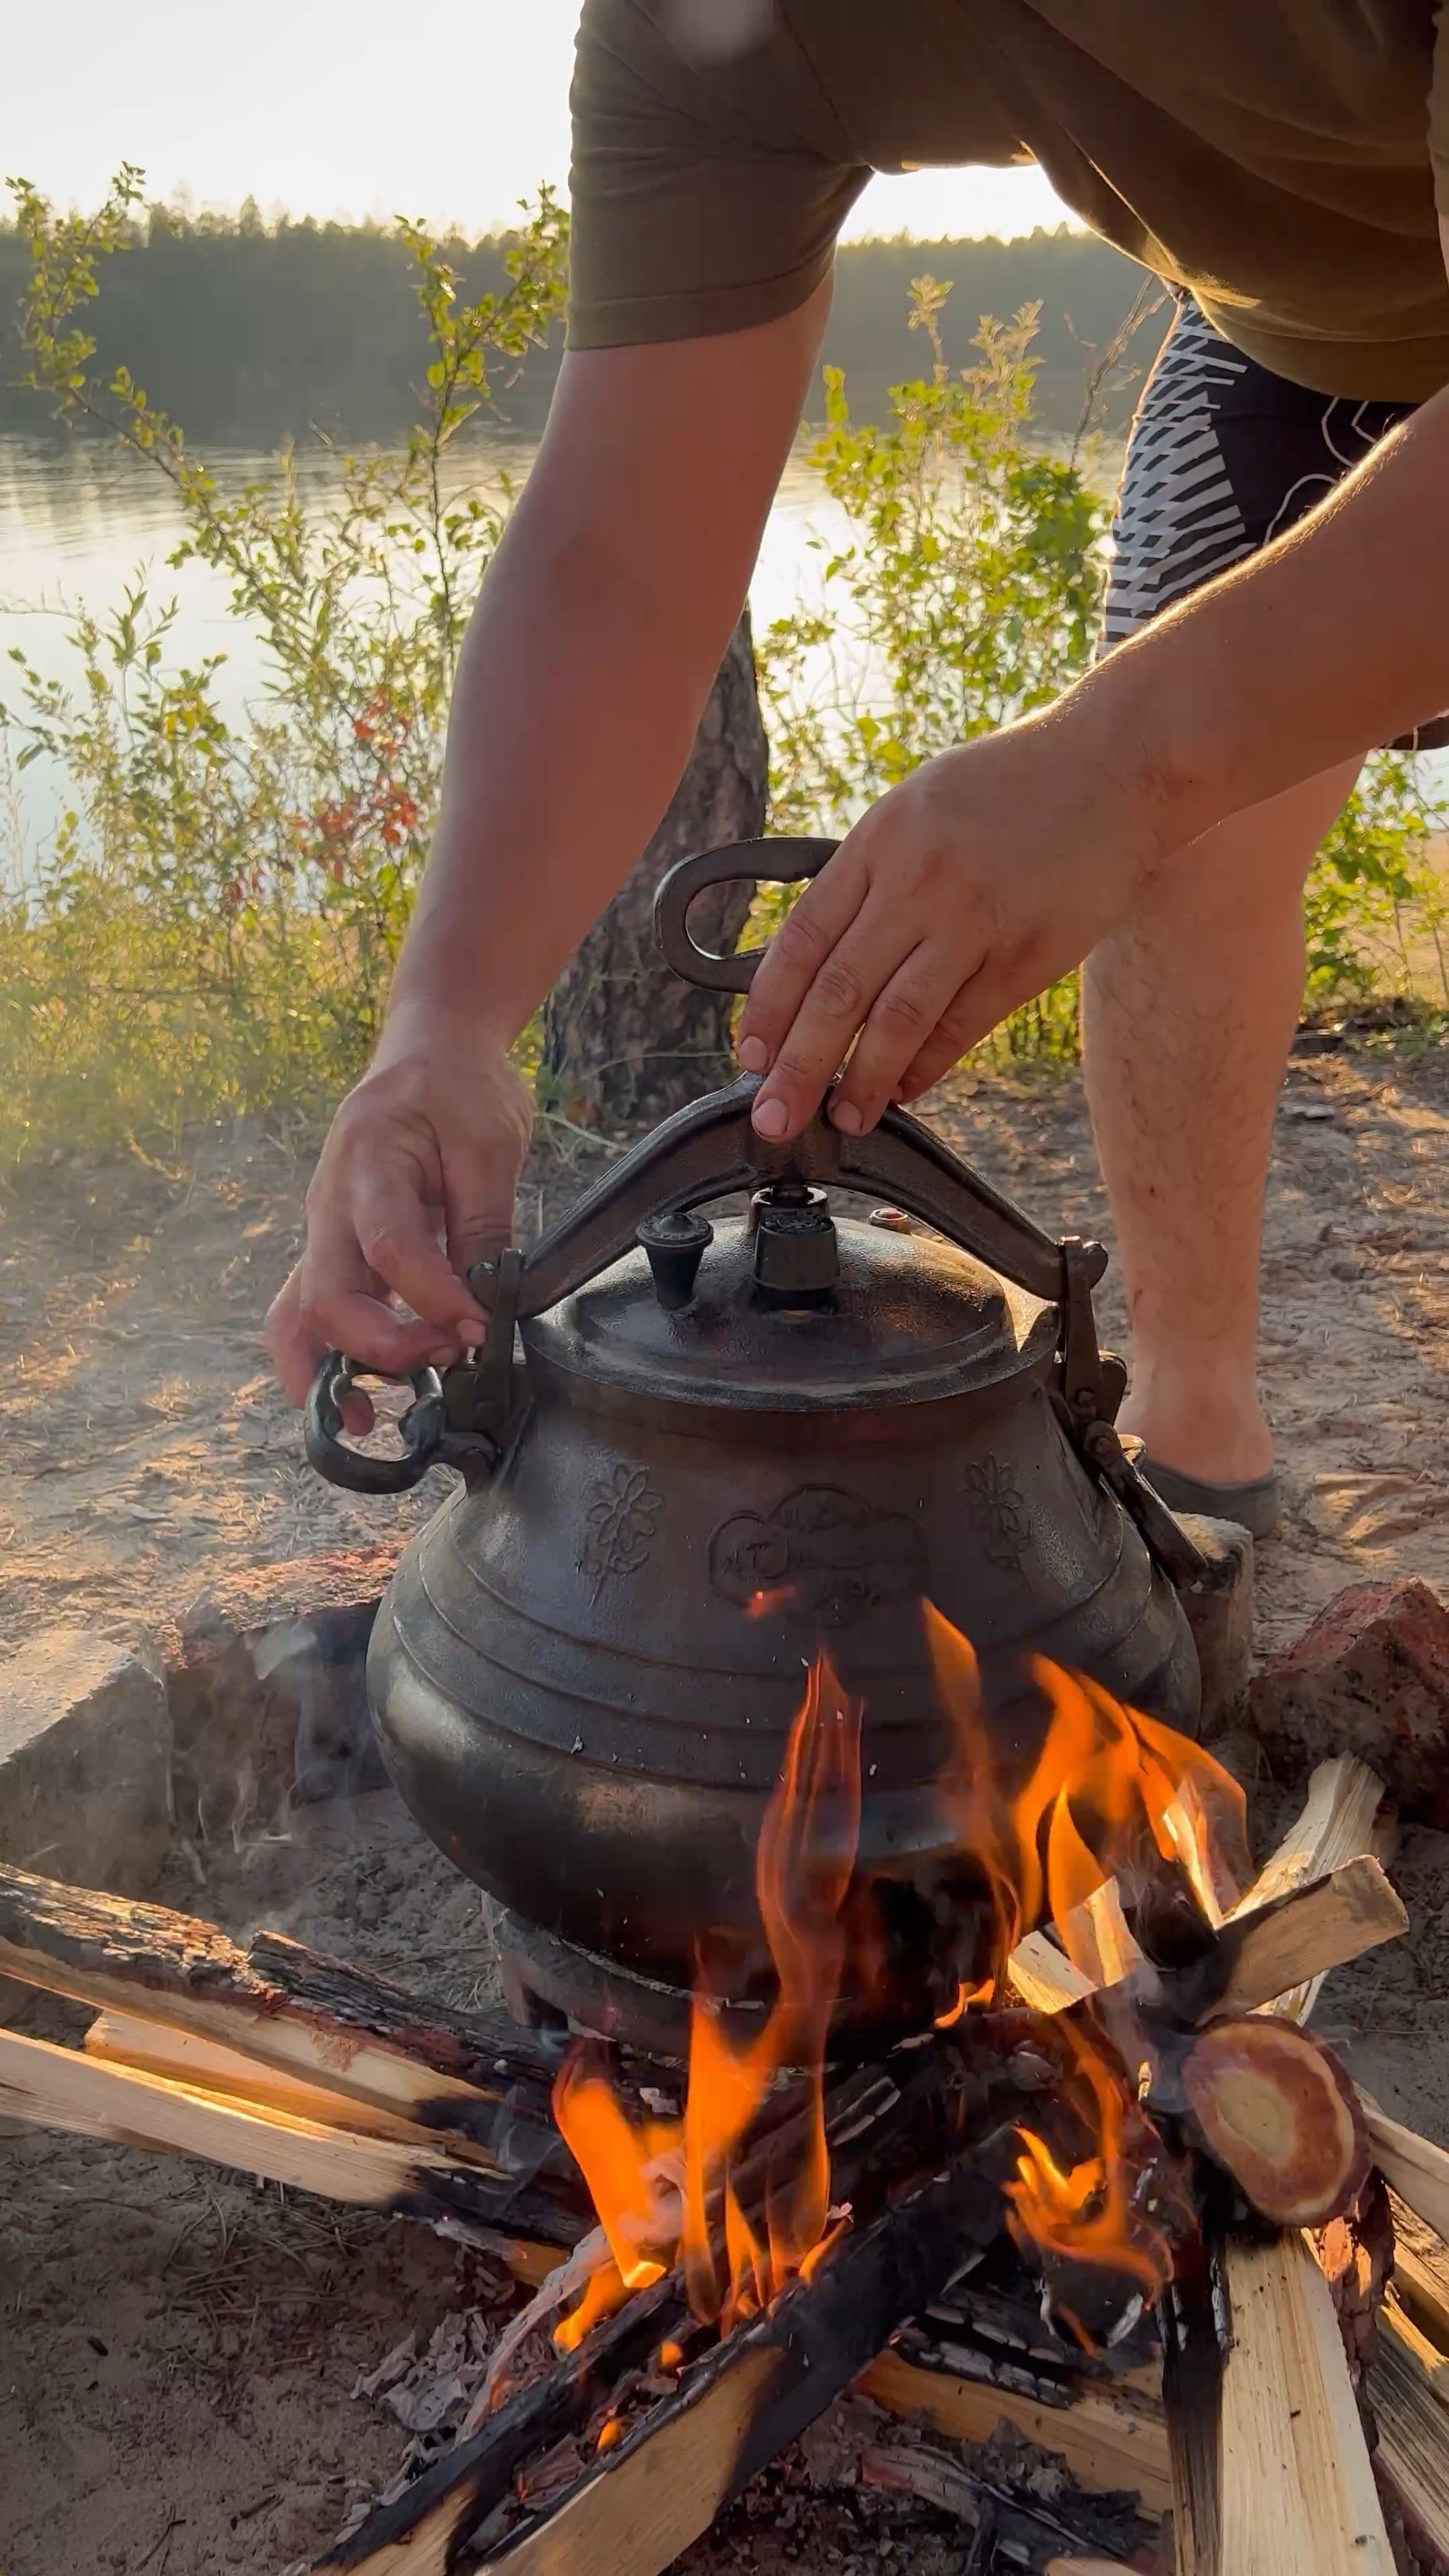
{"left": 0, "top": 0, "right": 1065, "bottom": 239}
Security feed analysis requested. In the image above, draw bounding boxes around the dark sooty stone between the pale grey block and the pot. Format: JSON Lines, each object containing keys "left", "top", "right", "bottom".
{"left": 170, "top": 1536, "right": 405, "bottom": 1839}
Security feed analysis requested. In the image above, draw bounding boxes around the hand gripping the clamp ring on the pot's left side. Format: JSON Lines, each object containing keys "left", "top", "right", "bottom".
{"left": 266, "top": 1002, "right": 531, "bottom": 1432}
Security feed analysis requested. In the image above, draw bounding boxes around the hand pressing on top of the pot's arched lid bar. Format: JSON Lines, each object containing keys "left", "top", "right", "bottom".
{"left": 737, "top": 703, "right": 1161, "bottom": 1138}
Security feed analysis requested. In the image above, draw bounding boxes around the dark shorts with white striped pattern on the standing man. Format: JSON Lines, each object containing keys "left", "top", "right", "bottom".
{"left": 1101, "top": 297, "right": 1449, "bottom": 752}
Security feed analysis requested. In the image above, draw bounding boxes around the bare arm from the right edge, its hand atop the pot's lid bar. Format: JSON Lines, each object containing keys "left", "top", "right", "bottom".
{"left": 740, "top": 227, "right": 1449, "bottom": 1136}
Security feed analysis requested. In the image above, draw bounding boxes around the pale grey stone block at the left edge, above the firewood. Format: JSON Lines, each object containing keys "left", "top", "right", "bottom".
{"left": 0, "top": 1628, "right": 170, "bottom": 1896}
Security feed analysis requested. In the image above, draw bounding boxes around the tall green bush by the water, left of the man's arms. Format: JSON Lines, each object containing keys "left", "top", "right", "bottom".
{"left": 0, "top": 170, "right": 568, "bottom": 1159}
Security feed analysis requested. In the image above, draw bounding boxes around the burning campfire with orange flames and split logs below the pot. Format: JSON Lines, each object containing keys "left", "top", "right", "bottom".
{"left": 0, "top": 1613, "right": 1449, "bottom": 2576}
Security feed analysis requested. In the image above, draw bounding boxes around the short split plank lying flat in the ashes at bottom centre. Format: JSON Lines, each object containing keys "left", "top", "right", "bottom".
{"left": 861, "top": 2352, "right": 1173, "bottom": 2514}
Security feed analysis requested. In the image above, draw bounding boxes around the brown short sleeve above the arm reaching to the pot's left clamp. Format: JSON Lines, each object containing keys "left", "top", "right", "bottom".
{"left": 570, "top": 0, "right": 871, "bottom": 347}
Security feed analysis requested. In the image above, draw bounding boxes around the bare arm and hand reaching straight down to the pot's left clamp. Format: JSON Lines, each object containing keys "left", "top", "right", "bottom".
{"left": 268, "top": 288, "right": 828, "bottom": 1399}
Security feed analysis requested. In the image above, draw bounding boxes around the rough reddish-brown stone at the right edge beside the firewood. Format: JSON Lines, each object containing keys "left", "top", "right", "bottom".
{"left": 1248, "top": 1574, "right": 1449, "bottom": 1829}
